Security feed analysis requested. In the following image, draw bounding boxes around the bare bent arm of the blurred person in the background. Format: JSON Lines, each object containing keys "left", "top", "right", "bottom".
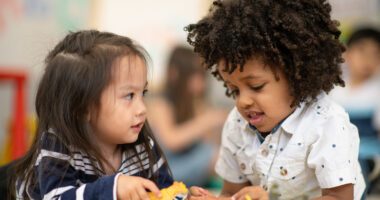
{"left": 149, "top": 99, "right": 226, "bottom": 151}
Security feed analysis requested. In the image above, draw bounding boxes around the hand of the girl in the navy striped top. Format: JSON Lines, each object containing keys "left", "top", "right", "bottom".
{"left": 116, "top": 174, "right": 161, "bottom": 200}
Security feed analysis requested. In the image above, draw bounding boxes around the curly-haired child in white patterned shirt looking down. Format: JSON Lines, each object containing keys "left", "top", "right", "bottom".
{"left": 187, "top": 0, "right": 365, "bottom": 200}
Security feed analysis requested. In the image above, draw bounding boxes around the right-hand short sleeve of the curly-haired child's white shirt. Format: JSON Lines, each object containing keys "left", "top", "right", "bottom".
{"left": 307, "top": 116, "right": 359, "bottom": 188}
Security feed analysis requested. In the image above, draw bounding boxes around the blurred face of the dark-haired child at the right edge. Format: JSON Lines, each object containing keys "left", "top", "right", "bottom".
{"left": 345, "top": 39, "right": 380, "bottom": 80}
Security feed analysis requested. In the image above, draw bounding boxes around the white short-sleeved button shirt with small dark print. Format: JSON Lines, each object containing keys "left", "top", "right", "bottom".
{"left": 215, "top": 93, "right": 365, "bottom": 199}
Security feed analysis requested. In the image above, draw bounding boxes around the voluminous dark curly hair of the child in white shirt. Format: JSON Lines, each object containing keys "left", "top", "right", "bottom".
{"left": 185, "top": 0, "right": 344, "bottom": 105}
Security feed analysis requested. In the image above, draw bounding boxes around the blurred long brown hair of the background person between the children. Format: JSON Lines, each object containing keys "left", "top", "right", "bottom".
{"left": 164, "top": 46, "right": 205, "bottom": 123}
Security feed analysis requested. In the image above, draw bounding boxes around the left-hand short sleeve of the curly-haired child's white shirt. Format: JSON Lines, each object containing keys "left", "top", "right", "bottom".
{"left": 215, "top": 108, "right": 248, "bottom": 183}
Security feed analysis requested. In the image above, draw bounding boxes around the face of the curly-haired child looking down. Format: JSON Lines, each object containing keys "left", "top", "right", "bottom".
{"left": 218, "top": 58, "right": 294, "bottom": 132}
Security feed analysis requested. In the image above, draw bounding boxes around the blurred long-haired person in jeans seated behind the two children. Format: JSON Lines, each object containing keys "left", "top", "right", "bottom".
{"left": 148, "top": 46, "right": 227, "bottom": 186}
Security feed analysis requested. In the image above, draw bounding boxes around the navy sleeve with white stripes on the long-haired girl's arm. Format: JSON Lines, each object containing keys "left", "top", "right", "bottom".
{"left": 36, "top": 157, "right": 119, "bottom": 200}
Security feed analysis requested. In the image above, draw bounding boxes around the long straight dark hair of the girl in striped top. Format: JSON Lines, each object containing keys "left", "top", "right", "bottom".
{"left": 12, "top": 30, "right": 169, "bottom": 198}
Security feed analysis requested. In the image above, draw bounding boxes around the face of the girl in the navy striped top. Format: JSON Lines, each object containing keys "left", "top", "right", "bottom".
{"left": 90, "top": 56, "right": 147, "bottom": 145}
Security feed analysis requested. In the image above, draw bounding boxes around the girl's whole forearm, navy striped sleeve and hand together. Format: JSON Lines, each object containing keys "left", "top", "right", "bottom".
{"left": 35, "top": 152, "right": 163, "bottom": 200}
